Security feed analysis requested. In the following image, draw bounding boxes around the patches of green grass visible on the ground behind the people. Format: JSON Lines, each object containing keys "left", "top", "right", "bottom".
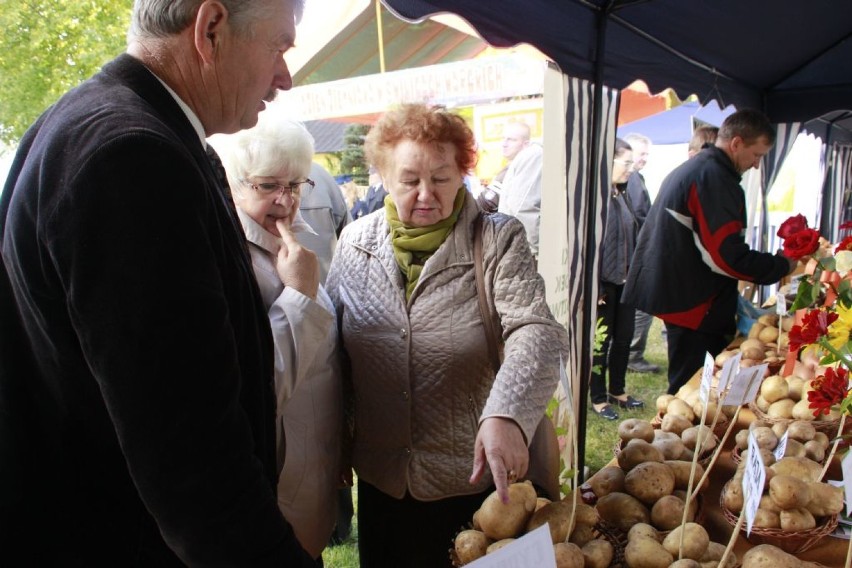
{"left": 322, "top": 318, "right": 668, "bottom": 568}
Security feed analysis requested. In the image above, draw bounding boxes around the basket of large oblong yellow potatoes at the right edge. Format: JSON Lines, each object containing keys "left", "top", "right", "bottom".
{"left": 722, "top": 448, "right": 844, "bottom": 532}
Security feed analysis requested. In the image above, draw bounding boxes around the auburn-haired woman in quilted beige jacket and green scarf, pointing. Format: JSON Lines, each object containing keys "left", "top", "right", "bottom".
{"left": 327, "top": 104, "right": 567, "bottom": 568}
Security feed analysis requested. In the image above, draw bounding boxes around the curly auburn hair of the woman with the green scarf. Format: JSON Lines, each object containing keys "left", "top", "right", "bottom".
{"left": 364, "top": 103, "right": 478, "bottom": 173}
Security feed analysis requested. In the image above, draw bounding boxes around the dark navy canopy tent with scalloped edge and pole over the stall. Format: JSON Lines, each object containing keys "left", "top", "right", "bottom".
{"left": 382, "top": 0, "right": 852, "bottom": 472}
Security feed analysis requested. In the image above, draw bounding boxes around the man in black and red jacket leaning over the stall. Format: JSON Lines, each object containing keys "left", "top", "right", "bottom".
{"left": 624, "top": 110, "right": 796, "bottom": 394}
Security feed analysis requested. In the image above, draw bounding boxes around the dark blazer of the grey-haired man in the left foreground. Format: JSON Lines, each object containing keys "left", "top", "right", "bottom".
{"left": 0, "top": 55, "right": 307, "bottom": 566}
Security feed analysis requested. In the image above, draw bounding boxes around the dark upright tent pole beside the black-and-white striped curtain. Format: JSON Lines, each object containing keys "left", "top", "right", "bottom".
{"left": 575, "top": 0, "right": 612, "bottom": 482}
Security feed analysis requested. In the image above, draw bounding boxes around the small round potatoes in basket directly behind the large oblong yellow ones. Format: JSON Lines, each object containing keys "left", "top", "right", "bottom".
{"left": 736, "top": 420, "right": 830, "bottom": 463}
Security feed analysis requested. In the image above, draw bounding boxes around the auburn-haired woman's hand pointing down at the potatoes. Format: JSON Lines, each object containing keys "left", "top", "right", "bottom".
{"left": 470, "top": 417, "right": 530, "bottom": 503}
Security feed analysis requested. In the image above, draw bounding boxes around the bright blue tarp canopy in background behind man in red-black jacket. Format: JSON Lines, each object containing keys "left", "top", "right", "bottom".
{"left": 618, "top": 101, "right": 735, "bottom": 144}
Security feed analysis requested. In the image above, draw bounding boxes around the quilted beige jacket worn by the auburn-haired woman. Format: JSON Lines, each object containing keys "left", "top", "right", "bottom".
{"left": 326, "top": 195, "right": 567, "bottom": 500}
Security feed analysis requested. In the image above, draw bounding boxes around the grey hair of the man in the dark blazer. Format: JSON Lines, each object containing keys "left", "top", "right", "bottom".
{"left": 127, "top": 0, "right": 305, "bottom": 39}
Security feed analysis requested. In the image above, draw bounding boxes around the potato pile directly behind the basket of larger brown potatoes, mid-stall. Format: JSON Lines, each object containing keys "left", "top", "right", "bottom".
{"left": 618, "top": 413, "right": 719, "bottom": 471}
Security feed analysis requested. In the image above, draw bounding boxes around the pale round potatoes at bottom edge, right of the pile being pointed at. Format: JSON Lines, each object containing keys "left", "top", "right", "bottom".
{"left": 624, "top": 523, "right": 737, "bottom": 568}
